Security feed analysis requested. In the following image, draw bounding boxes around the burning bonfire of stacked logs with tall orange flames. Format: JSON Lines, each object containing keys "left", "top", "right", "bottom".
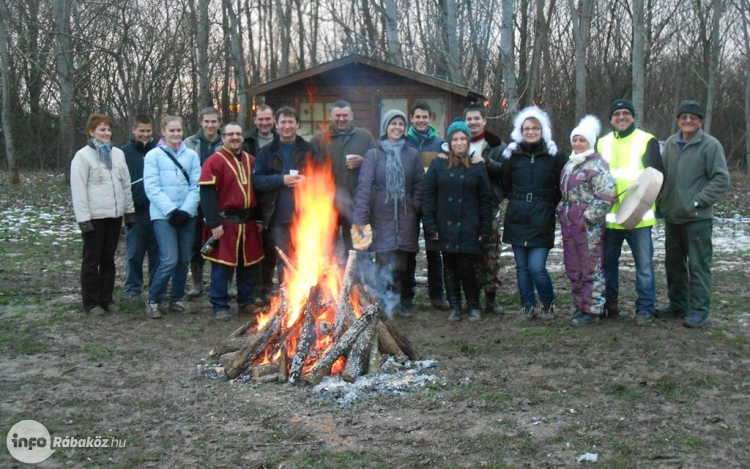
{"left": 210, "top": 159, "right": 421, "bottom": 384}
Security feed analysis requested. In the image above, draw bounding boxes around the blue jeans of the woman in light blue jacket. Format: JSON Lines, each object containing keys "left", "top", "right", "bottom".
{"left": 148, "top": 217, "right": 195, "bottom": 301}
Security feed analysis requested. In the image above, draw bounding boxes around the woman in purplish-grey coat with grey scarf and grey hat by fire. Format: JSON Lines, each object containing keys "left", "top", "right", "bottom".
{"left": 354, "top": 109, "right": 424, "bottom": 316}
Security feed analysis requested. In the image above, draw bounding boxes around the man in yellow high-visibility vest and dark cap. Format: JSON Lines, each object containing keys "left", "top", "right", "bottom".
{"left": 596, "top": 99, "right": 664, "bottom": 326}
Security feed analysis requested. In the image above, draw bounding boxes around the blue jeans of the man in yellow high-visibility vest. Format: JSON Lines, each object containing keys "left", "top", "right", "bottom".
{"left": 604, "top": 226, "right": 656, "bottom": 314}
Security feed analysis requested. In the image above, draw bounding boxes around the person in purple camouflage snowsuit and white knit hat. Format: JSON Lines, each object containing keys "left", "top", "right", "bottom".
{"left": 557, "top": 116, "right": 615, "bottom": 326}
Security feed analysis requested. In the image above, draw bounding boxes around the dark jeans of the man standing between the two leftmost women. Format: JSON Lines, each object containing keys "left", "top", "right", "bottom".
{"left": 125, "top": 209, "right": 159, "bottom": 296}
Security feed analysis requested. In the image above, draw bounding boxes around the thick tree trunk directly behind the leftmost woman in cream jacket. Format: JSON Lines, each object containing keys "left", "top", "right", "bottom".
{"left": 53, "top": 0, "right": 75, "bottom": 174}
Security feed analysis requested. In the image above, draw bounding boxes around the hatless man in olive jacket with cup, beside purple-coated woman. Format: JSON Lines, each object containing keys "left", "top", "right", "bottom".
{"left": 310, "top": 100, "right": 375, "bottom": 263}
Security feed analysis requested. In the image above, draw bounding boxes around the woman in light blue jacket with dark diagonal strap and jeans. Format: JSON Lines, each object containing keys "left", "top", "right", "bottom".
{"left": 143, "top": 116, "right": 201, "bottom": 319}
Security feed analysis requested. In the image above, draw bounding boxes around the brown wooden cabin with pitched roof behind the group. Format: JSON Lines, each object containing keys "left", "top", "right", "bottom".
{"left": 250, "top": 54, "right": 486, "bottom": 140}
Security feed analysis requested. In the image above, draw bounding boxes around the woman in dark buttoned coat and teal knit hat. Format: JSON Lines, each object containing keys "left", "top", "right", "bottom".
{"left": 422, "top": 119, "right": 492, "bottom": 321}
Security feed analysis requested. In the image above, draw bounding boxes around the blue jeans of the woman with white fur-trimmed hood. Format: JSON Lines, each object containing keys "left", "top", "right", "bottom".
{"left": 513, "top": 246, "right": 555, "bottom": 307}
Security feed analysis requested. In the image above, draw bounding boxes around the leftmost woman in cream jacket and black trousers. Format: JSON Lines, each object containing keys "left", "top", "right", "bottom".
{"left": 70, "top": 114, "right": 135, "bottom": 315}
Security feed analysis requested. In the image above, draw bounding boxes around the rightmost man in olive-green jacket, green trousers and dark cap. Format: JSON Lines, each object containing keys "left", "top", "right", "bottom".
{"left": 656, "top": 100, "right": 729, "bottom": 327}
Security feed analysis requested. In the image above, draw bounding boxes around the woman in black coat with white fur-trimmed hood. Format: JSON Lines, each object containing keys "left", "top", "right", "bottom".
{"left": 500, "top": 106, "right": 568, "bottom": 319}
